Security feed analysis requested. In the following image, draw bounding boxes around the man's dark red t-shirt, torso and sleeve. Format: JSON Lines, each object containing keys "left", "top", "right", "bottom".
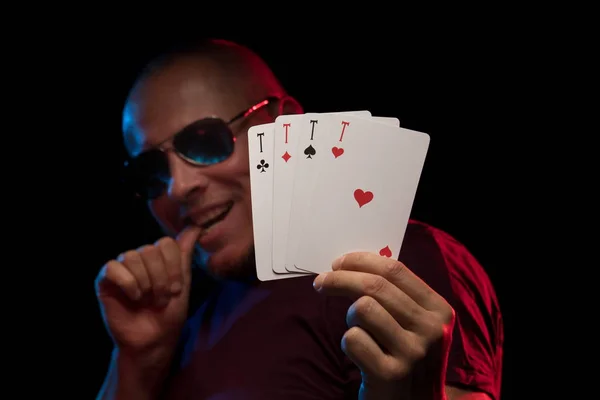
{"left": 161, "top": 221, "right": 503, "bottom": 400}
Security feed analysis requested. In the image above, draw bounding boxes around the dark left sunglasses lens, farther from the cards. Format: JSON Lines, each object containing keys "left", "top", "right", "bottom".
{"left": 127, "top": 150, "right": 169, "bottom": 199}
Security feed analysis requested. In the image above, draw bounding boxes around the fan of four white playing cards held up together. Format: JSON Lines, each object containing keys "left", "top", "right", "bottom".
{"left": 248, "top": 111, "right": 429, "bottom": 281}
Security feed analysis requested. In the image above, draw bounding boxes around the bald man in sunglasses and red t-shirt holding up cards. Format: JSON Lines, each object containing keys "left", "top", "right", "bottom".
{"left": 96, "top": 41, "right": 503, "bottom": 400}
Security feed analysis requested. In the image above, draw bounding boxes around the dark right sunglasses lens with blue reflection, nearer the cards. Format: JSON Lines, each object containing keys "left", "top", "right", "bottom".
{"left": 173, "top": 118, "right": 234, "bottom": 165}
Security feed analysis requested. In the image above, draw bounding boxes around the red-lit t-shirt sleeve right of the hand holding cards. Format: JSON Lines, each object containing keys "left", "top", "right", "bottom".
{"left": 399, "top": 221, "right": 504, "bottom": 400}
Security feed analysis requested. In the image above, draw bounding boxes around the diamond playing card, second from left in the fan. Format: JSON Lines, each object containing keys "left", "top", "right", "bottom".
{"left": 272, "top": 111, "right": 371, "bottom": 274}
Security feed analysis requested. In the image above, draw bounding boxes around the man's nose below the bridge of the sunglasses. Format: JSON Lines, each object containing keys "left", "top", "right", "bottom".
{"left": 167, "top": 152, "right": 208, "bottom": 203}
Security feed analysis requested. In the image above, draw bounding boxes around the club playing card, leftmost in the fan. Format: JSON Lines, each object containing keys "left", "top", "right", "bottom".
{"left": 248, "top": 124, "right": 305, "bottom": 281}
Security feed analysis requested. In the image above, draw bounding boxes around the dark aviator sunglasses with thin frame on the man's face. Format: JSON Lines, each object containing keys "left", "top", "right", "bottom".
{"left": 123, "top": 97, "right": 280, "bottom": 199}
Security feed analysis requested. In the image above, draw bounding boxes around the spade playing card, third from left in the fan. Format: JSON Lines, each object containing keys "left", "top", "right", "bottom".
{"left": 282, "top": 114, "right": 400, "bottom": 273}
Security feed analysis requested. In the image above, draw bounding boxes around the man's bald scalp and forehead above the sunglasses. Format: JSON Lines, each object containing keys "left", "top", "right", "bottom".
{"left": 123, "top": 39, "right": 286, "bottom": 152}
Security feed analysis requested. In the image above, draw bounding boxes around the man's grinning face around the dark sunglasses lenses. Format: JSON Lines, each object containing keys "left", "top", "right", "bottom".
{"left": 124, "top": 66, "right": 272, "bottom": 278}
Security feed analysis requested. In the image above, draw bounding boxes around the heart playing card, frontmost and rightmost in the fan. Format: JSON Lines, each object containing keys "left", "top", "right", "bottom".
{"left": 290, "top": 115, "right": 429, "bottom": 273}
